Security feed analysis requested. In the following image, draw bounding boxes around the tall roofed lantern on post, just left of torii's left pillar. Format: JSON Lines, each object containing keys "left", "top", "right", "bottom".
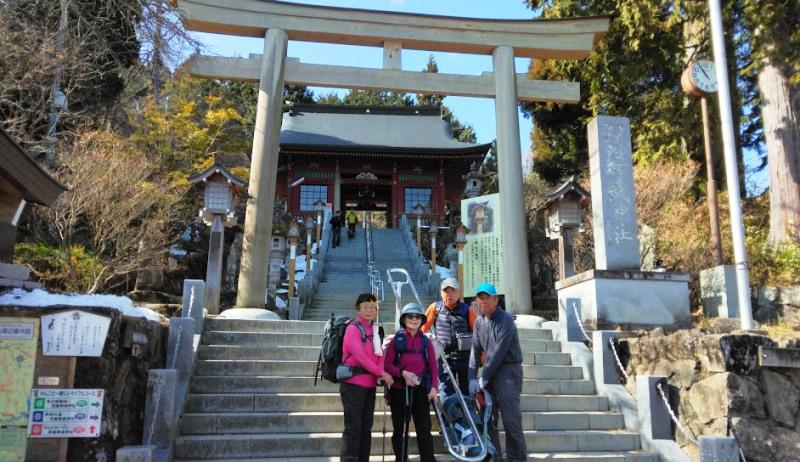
{"left": 189, "top": 162, "right": 245, "bottom": 314}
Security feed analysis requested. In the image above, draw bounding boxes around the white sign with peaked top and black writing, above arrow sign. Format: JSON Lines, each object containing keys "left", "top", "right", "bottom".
{"left": 42, "top": 311, "right": 111, "bottom": 356}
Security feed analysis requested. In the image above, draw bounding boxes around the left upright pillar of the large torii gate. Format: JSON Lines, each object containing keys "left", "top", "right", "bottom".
{"left": 236, "top": 29, "right": 288, "bottom": 308}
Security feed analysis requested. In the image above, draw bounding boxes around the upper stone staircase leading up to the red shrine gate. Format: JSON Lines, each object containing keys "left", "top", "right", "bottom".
{"left": 303, "top": 228, "right": 435, "bottom": 320}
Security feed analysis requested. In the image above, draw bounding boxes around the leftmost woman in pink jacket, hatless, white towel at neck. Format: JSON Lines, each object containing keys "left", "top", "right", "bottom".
{"left": 339, "top": 294, "right": 392, "bottom": 462}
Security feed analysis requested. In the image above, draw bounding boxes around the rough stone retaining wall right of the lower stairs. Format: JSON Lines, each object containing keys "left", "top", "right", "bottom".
{"left": 620, "top": 329, "right": 800, "bottom": 462}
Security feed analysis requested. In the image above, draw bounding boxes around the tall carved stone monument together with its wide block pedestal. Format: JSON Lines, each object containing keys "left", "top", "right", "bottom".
{"left": 556, "top": 116, "right": 691, "bottom": 332}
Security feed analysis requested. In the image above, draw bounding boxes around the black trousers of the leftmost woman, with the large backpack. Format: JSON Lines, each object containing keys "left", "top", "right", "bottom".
{"left": 339, "top": 383, "right": 375, "bottom": 462}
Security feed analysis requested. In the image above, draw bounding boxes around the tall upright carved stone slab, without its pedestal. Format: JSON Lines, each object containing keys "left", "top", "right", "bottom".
{"left": 588, "top": 116, "right": 640, "bottom": 270}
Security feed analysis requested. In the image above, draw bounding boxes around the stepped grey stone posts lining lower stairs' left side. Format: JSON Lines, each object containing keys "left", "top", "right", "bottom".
{"left": 117, "top": 279, "right": 205, "bottom": 462}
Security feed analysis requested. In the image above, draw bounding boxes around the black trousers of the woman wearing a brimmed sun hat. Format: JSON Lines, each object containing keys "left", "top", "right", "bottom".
{"left": 389, "top": 386, "right": 436, "bottom": 462}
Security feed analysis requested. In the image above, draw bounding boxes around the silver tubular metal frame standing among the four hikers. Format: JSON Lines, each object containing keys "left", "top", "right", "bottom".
{"left": 386, "top": 268, "right": 488, "bottom": 462}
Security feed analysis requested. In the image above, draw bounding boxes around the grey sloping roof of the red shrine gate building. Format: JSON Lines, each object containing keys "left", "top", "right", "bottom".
{"left": 280, "top": 104, "right": 491, "bottom": 156}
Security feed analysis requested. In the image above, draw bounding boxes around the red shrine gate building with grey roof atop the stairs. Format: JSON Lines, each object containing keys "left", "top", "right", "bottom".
{"left": 276, "top": 104, "right": 491, "bottom": 227}
